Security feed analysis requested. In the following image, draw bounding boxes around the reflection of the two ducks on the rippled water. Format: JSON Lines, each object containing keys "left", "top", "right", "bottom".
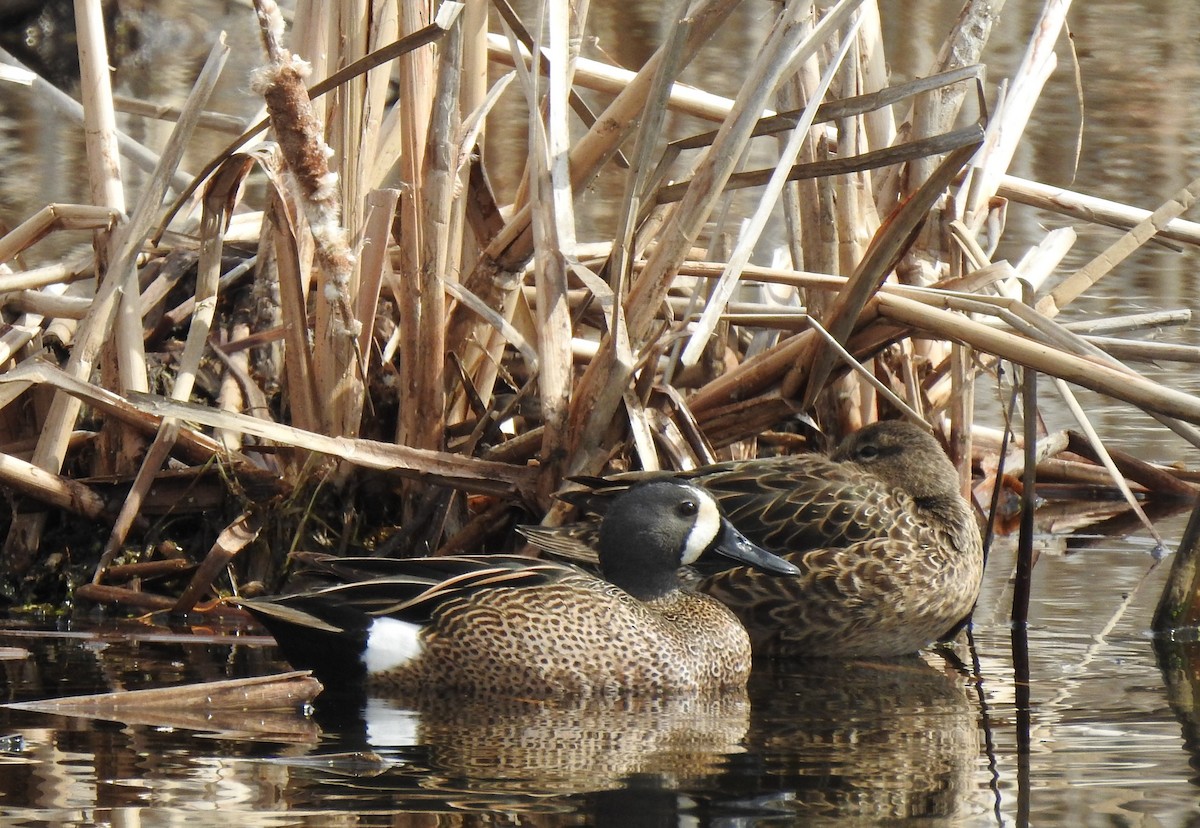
{"left": 295, "top": 658, "right": 985, "bottom": 826}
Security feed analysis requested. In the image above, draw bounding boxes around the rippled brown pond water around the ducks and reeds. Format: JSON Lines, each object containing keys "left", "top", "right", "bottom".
{"left": 0, "top": 0, "right": 1200, "bottom": 826}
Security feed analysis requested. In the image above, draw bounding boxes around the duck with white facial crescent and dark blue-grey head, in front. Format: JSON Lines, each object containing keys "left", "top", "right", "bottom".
{"left": 239, "top": 481, "right": 797, "bottom": 697}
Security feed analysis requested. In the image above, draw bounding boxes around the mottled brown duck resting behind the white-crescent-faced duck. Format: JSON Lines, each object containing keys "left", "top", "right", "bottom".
{"left": 522, "top": 421, "right": 983, "bottom": 658}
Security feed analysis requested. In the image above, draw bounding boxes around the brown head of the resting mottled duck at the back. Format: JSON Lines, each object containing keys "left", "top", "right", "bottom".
{"left": 833, "top": 420, "right": 959, "bottom": 503}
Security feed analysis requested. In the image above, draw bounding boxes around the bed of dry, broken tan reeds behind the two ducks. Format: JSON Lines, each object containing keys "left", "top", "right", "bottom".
{"left": 0, "top": 0, "right": 1200, "bottom": 610}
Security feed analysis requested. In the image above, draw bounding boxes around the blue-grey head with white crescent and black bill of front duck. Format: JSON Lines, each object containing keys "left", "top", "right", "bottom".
{"left": 599, "top": 480, "right": 799, "bottom": 600}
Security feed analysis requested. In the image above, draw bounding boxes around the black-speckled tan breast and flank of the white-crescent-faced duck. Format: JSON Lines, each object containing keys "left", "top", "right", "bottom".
{"left": 370, "top": 574, "right": 750, "bottom": 697}
